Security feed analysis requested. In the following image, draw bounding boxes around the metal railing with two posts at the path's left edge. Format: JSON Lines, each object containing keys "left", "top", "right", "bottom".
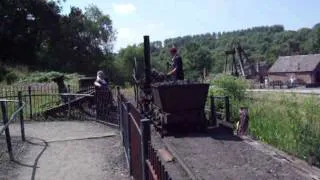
{"left": 0, "top": 92, "right": 26, "bottom": 161}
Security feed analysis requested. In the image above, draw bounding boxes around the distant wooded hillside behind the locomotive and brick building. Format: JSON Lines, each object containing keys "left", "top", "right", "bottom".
{"left": 117, "top": 23, "right": 320, "bottom": 79}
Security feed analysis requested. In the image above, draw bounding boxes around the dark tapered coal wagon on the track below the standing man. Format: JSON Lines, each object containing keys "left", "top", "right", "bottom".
{"left": 151, "top": 81, "right": 209, "bottom": 135}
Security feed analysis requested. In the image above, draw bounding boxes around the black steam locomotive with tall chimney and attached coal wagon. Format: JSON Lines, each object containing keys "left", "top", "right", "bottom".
{"left": 133, "top": 38, "right": 209, "bottom": 136}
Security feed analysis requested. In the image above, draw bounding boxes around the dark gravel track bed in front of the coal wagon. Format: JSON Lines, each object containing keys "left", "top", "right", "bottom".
{"left": 164, "top": 127, "right": 320, "bottom": 180}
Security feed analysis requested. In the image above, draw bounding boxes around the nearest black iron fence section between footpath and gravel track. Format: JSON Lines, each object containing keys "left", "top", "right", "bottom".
{"left": 117, "top": 90, "right": 171, "bottom": 180}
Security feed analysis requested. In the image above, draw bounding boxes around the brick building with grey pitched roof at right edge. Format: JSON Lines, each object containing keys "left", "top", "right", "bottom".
{"left": 268, "top": 54, "right": 320, "bottom": 84}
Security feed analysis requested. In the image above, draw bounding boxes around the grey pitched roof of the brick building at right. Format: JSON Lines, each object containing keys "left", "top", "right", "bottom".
{"left": 269, "top": 54, "right": 320, "bottom": 73}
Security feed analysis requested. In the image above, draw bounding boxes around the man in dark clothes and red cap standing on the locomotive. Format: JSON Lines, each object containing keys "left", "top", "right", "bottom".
{"left": 167, "top": 48, "right": 184, "bottom": 81}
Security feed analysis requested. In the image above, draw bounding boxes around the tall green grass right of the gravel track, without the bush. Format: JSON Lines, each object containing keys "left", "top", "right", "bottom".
{"left": 243, "top": 93, "right": 320, "bottom": 166}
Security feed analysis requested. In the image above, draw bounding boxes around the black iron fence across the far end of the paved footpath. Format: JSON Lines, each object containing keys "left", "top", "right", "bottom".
{"left": 0, "top": 83, "right": 105, "bottom": 120}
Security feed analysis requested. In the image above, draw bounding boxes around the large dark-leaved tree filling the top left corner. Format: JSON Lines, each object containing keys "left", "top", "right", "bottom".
{"left": 0, "top": 0, "right": 61, "bottom": 66}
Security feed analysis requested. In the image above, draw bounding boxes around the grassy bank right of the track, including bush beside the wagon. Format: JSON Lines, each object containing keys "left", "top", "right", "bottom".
{"left": 210, "top": 75, "right": 320, "bottom": 167}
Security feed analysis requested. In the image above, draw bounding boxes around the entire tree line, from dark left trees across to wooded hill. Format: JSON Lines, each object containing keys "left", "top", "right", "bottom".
{"left": 0, "top": 0, "right": 320, "bottom": 84}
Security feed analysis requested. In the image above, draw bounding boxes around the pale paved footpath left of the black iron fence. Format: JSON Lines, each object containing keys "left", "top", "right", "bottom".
{"left": 0, "top": 121, "right": 129, "bottom": 180}
